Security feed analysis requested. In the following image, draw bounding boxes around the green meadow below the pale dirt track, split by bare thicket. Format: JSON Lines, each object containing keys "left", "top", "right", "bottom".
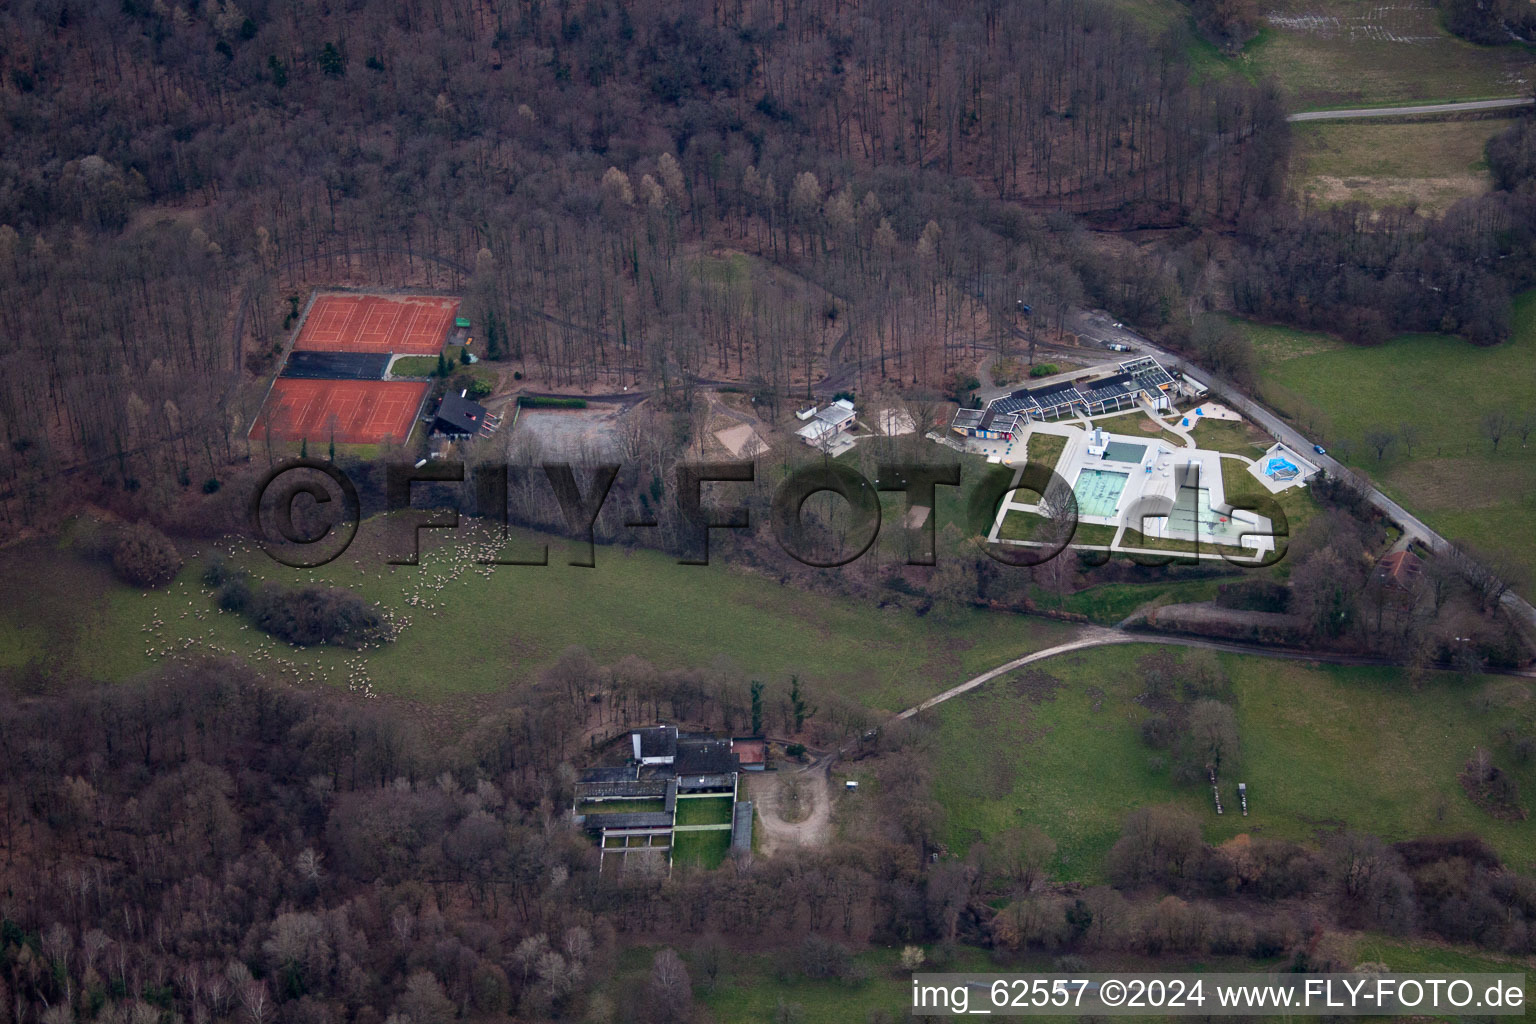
{"left": 932, "top": 645, "right": 1536, "bottom": 881}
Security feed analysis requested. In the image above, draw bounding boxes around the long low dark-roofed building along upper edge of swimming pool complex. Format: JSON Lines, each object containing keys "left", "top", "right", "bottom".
{"left": 951, "top": 356, "right": 1175, "bottom": 441}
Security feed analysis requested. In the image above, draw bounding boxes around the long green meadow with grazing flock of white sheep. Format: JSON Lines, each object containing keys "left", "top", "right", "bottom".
{"left": 0, "top": 515, "right": 1066, "bottom": 711}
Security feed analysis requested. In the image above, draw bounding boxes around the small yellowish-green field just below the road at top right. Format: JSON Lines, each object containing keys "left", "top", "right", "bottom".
{"left": 1290, "top": 118, "right": 1511, "bottom": 212}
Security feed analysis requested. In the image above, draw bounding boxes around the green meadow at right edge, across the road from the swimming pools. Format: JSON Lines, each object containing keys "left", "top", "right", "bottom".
{"left": 1246, "top": 292, "right": 1536, "bottom": 576}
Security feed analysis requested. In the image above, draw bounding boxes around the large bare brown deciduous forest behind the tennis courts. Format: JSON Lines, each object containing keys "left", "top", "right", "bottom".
{"left": 0, "top": 2, "right": 1284, "bottom": 515}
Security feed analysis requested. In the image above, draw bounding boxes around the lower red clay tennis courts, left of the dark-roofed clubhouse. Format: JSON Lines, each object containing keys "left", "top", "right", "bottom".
{"left": 250, "top": 378, "right": 429, "bottom": 444}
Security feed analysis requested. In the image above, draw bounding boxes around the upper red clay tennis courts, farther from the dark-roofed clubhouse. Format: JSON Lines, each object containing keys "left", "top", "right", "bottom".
{"left": 293, "top": 295, "right": 459, "bottom": 356}
